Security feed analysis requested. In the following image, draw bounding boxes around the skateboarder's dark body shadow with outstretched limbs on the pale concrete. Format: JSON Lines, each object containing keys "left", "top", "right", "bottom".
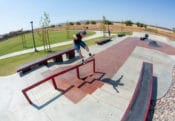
{"left": 101, "top": 75, "right": 124, "bottom": 93}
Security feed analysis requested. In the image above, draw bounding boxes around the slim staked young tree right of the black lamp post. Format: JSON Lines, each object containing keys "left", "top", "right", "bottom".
{"left": 39, "top": 12, "right": 51, "bottom": 51}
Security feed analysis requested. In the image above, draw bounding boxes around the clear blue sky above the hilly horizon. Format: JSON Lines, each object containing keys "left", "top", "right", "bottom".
{"left": 0, "top": 0, "right": 175, "bottom": 34}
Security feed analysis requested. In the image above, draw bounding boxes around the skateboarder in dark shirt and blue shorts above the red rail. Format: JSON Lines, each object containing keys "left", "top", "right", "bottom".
{"left": 73, "top": 27, "right": 92, "bottom": 64}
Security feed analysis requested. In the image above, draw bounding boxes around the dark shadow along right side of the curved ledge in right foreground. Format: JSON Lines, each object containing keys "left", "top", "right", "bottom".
{"left": 147, "top": 76, "right": 158, "bottom": 121}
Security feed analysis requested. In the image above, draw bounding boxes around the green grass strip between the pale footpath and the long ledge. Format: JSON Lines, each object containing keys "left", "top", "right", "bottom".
{"left": 0, "top": 37, "right": 108, "bottom": 76}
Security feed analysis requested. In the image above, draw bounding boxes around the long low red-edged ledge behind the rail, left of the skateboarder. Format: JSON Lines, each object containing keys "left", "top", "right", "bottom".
{"left": 16, "top": 48, "right": 75, "bottom": 73}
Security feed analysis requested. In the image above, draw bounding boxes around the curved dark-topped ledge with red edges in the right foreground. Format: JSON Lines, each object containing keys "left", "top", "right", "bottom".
{"left": 121, "top": 62, "right": 153, "bottom": 121}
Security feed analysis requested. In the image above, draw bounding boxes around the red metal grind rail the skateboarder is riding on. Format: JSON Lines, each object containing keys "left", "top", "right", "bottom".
{"left": 22, "top": 58, "right": 95, "bottom": 104}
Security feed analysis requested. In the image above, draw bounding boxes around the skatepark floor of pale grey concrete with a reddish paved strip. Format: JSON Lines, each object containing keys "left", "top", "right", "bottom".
{"left": 0, "top": 33, "right": 175, "bottom": 121}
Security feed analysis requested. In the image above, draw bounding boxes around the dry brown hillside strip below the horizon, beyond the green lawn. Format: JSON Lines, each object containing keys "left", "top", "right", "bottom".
{"left": 50, "top": 23, "right": 175, "bottom": 41}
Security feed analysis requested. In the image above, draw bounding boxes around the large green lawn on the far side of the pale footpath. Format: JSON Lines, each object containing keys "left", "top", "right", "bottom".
{"left": 0, "top": 31, "right": 95, "bottom": 56}
